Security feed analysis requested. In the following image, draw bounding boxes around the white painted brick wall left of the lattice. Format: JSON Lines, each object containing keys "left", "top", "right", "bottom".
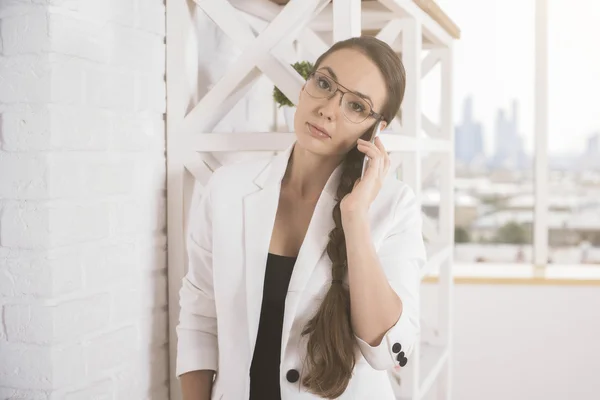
{"left": 0, "top": 0, "right": 168, "bottom": 400}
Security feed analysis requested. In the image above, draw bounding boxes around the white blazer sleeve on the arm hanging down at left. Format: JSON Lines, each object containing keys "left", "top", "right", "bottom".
{"left": 176, "top": 174, "right": 218, "bottom": 377}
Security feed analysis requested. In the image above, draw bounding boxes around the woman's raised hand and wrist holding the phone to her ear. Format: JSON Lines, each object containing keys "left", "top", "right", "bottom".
{"left": 340, "top": 137, "right": 390, "bottom": 220}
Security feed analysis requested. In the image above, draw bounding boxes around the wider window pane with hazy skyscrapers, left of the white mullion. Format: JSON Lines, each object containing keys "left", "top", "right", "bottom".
{"left": 432, "top": 0, "right": 535, "bottom": 263}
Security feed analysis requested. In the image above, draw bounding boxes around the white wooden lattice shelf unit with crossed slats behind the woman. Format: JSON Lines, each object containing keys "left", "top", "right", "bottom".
{"left": 167, "top": 0, "right": 454, "bottom": 400}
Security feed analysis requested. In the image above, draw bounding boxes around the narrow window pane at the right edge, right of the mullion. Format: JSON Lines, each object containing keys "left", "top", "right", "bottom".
{"left": 548, "top": 0, "right": 600, "bottom": 265}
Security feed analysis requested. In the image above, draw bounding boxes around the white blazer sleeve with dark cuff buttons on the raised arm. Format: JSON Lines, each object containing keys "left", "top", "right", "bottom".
{"left": 356, "top": 186, "right": 426, "bottom": 370}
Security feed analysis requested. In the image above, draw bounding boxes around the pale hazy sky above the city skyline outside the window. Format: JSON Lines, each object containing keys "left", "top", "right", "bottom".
{"left": 423, "top": 0, "right": 600, "bottom": 155}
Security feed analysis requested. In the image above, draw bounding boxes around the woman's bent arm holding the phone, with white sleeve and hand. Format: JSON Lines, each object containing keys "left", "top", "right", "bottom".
{"left": 340, "top": 138, "right": 426, "bottom": 370}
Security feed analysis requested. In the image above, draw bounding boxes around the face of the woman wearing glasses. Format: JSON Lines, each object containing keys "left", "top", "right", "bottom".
{"left": 294, "top": 49, "right": 387, "bottom": 156}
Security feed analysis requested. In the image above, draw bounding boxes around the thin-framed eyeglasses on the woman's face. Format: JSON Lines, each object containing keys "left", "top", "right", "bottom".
{"left": 305, "top": 71, "right": 383, "bottom": 124}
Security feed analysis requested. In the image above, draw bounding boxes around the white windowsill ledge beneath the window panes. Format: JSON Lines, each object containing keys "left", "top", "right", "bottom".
{"left": 423, "top": 263, "right": 600, "bottom": 286}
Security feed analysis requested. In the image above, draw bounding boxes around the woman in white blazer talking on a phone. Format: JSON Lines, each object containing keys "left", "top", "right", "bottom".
{"left": 177, "top": 37, "right": 425, "bottom": 400}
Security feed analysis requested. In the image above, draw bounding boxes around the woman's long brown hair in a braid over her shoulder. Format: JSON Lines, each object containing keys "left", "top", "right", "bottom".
{"left": 302, "top": 36, "right": 406, "bottom": 399}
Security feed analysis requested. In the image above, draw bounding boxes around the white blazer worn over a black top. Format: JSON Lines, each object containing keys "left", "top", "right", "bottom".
{"left": 176, "top": 145, "right": 425, "bottom": 400}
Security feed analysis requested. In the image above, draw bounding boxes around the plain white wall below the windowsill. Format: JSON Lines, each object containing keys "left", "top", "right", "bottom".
{"left": 422, "top": 284, "right": 600, "bottom": 400}
